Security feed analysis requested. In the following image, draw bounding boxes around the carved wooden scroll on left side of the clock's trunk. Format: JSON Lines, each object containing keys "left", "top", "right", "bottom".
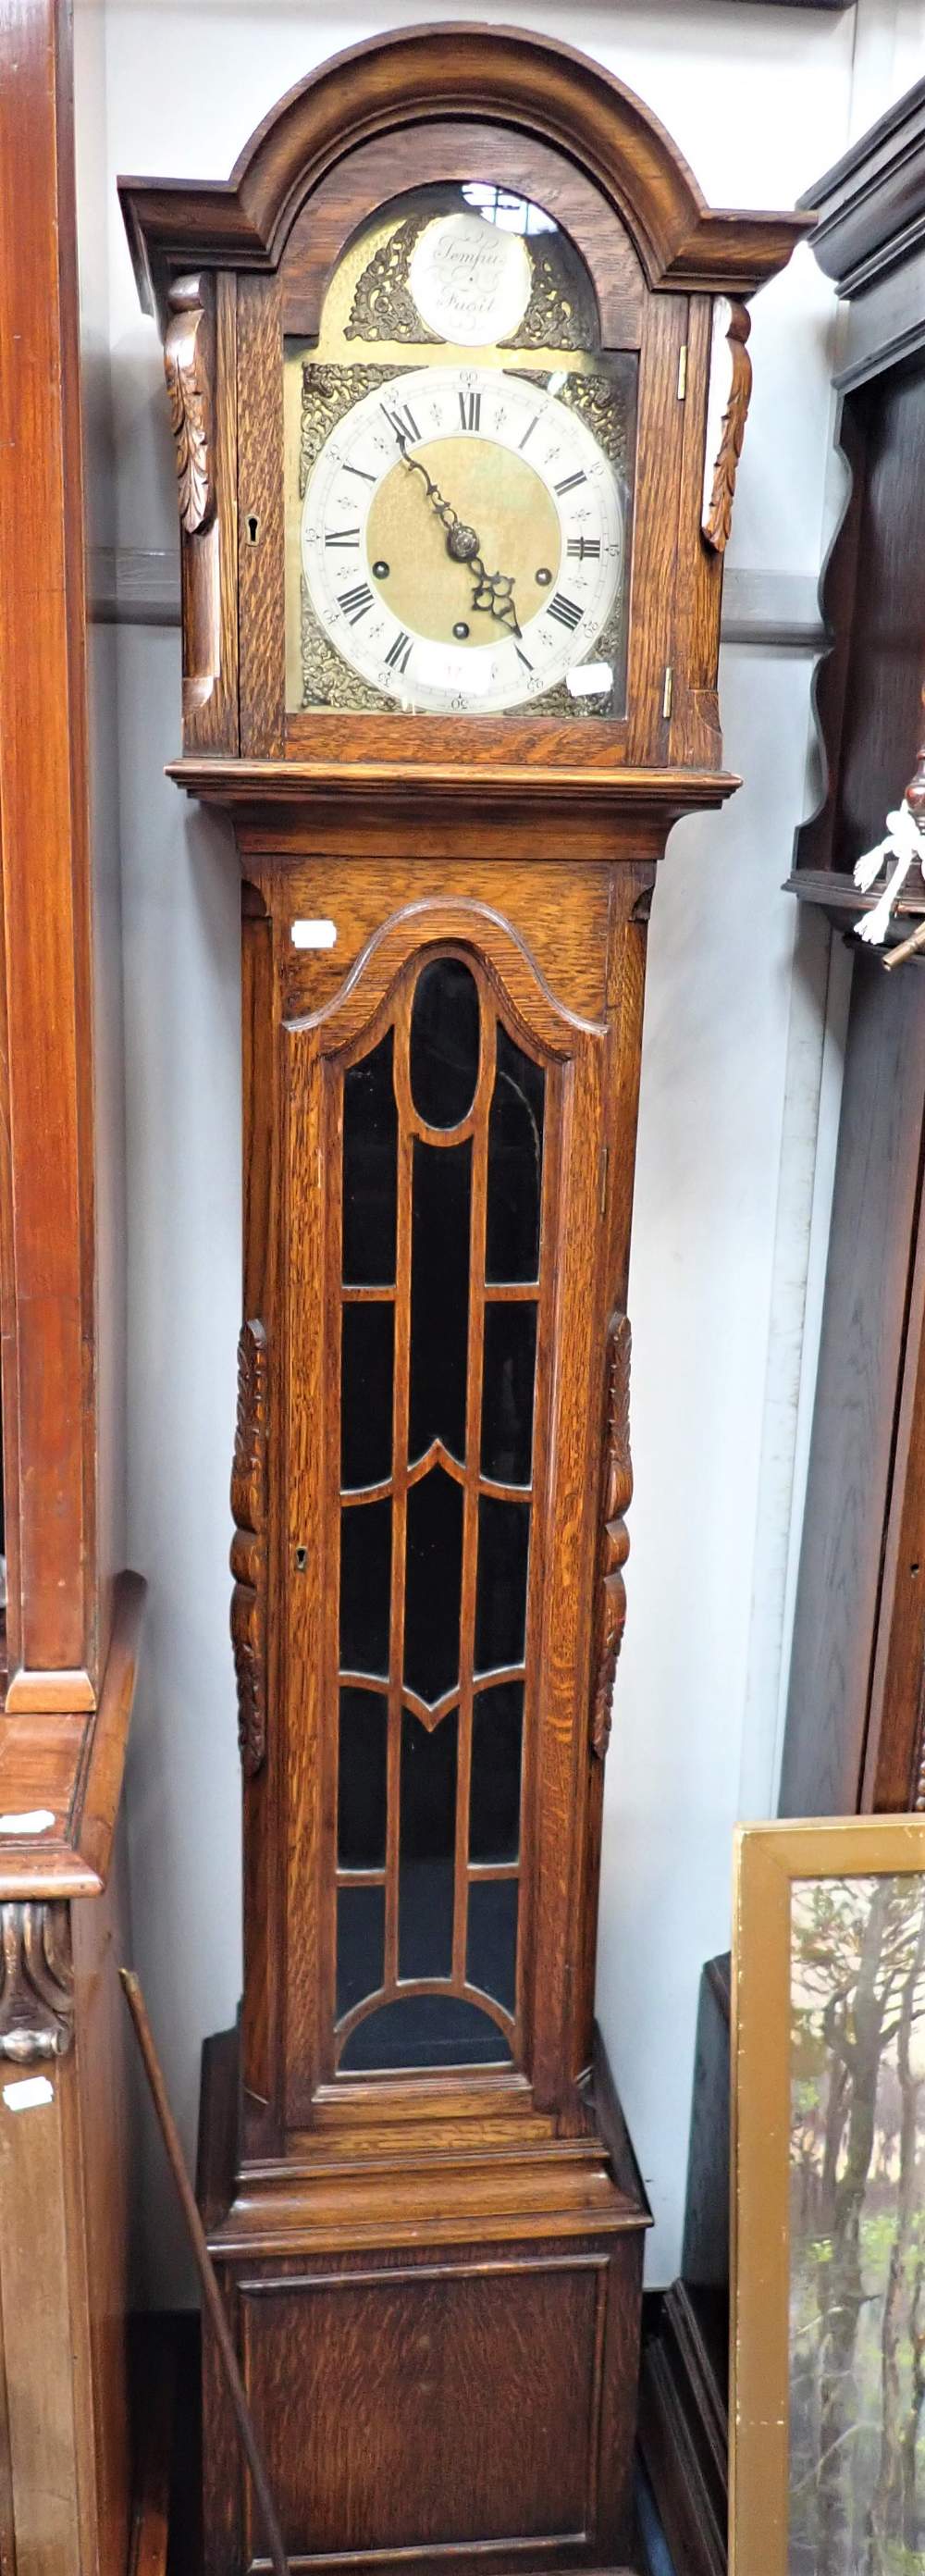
{"left": 232, "top": 1321, "right": 268, "bottom": 1780}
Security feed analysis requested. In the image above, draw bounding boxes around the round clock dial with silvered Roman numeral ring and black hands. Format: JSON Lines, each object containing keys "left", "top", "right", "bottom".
{"left": 302, "top": 365, "right": 623, "bottom": 713}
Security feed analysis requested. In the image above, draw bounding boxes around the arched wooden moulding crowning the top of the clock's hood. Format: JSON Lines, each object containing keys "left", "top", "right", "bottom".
{"left": 118, "top": 23, "right": 814, "bottom": 322}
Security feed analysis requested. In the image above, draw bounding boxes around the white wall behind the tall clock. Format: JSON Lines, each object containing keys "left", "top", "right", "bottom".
{"left": 78, "top": 0, "right": 896, "bottom": 2300}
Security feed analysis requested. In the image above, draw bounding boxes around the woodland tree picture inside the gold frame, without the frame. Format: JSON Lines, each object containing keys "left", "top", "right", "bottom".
{"left": 788, "top": 1876, "right": 925, "bottom": 2576}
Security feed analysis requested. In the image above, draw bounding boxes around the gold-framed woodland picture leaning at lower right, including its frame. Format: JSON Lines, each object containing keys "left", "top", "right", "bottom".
{"left": 729, "top": 1816, "right": 925, "bottom": 2576}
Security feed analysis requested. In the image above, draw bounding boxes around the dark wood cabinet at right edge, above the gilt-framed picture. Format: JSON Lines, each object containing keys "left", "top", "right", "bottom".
{"left": 781, "top": 82, "right": 925, "bottom": 1816}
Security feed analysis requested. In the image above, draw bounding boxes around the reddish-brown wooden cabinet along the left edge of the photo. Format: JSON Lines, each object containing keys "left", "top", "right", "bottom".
{"left": 0, "top": 0, "right": 144, "bottom": 2576}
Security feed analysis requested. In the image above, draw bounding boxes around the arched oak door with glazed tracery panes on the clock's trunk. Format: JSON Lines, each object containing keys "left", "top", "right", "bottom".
{"left": 283, "top": 901, "right": 608, "bottom": 2128}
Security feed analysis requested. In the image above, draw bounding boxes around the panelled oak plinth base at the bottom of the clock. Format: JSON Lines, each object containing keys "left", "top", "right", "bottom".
{"left": 198, "top": 2033, "right": 649, "bottom": 2576}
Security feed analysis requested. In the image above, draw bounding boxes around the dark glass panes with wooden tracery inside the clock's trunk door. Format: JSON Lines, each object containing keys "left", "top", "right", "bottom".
{"left": 338, "top": 956, "right": 547, "bottom": 2074}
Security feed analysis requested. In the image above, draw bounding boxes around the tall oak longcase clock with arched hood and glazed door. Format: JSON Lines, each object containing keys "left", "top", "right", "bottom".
{"left": 121, "top": 26, "right": 807, "bottom": 2576}
